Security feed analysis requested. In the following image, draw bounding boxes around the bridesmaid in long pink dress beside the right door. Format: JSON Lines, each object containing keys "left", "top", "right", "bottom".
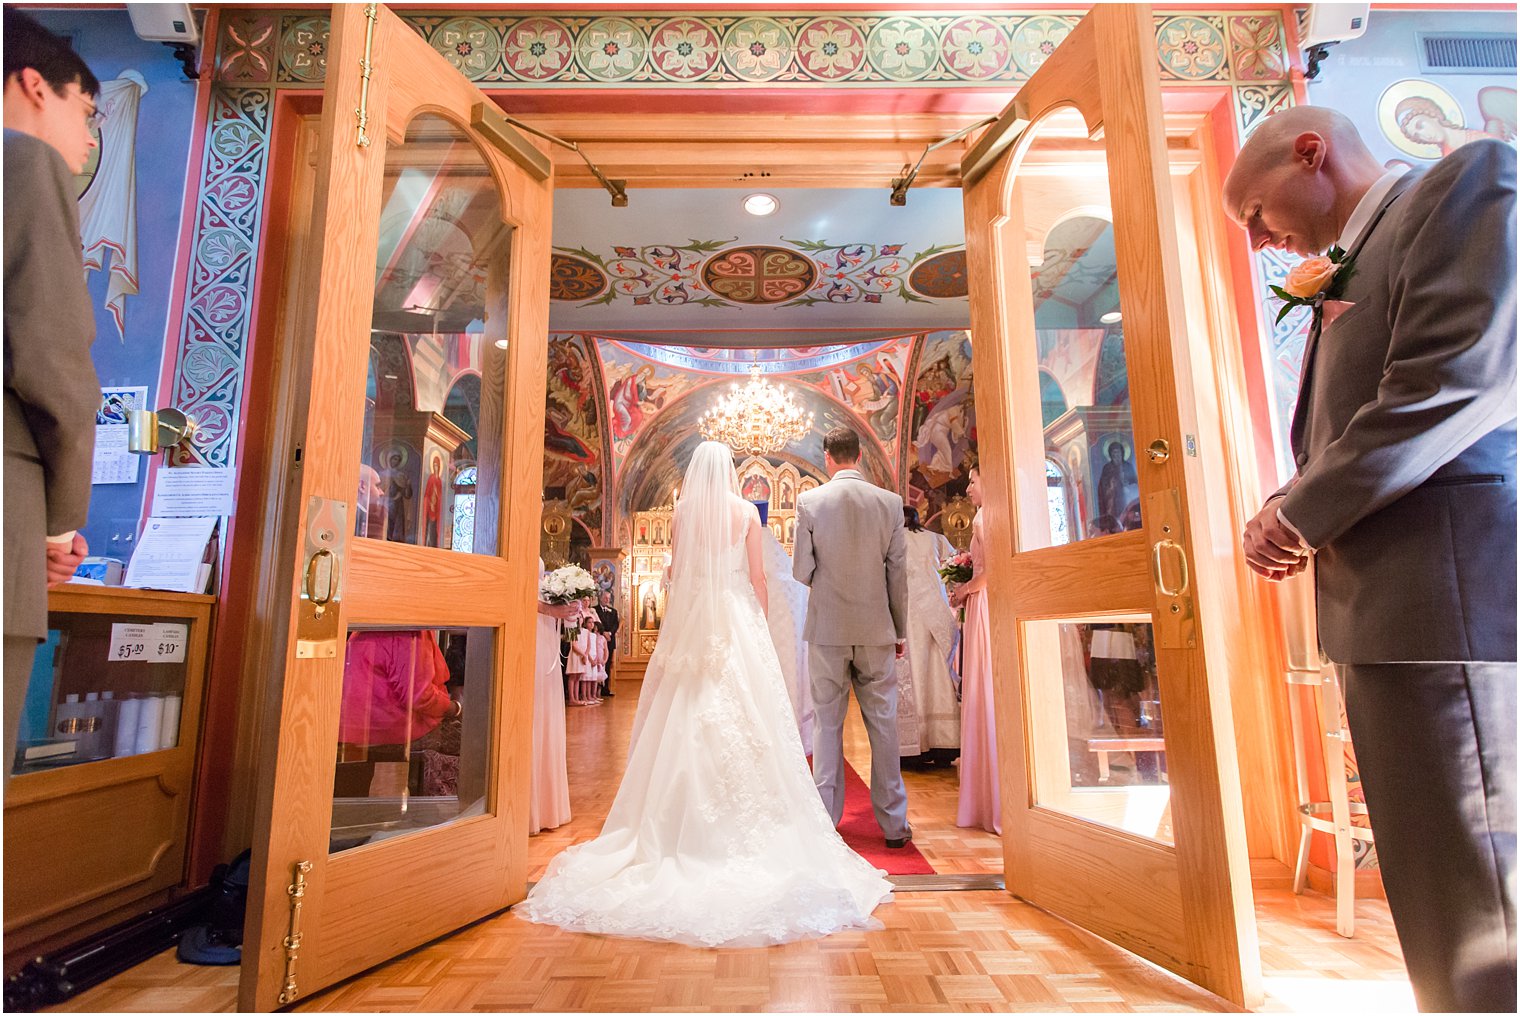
{"left": 950, "top": 465, "right": 1003, "bottom": 833}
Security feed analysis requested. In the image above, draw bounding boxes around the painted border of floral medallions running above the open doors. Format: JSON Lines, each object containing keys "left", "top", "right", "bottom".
{"left": 255, "top": 8, "right": 1287, "bottom": 88}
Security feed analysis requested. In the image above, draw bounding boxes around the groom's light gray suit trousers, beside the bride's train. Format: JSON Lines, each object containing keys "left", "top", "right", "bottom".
{"left": 807, "top": 642, "right": 909, "bottom": 840}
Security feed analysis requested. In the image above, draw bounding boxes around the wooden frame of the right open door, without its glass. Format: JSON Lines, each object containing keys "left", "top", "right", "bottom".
{"left": 962, "top": 5, "right": 1262, "bottom": 1004}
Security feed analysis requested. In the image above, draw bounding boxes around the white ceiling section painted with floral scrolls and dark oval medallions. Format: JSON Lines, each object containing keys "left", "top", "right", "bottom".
{"left": 550, "top": 189, "right": 970, "bottom": 333}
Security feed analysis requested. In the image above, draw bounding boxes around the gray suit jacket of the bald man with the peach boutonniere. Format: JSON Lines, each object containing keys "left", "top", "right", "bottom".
{"left": 1280, "top": 141, "right": 1515, "bottom": 663}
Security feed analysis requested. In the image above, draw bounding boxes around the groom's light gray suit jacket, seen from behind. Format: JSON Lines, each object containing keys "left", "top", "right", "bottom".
{"left": 792, "top": 470, "right": 907, "bottom": 645}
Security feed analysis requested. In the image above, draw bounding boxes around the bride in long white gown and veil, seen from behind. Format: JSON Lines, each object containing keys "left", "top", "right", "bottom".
{"left": 514, "top": 441, "right": 892, "bottom": 946}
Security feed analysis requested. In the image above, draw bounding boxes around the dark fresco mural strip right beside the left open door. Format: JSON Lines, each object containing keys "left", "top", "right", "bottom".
{"left": 544, "top": 335, "right": 606, "bottom": 543}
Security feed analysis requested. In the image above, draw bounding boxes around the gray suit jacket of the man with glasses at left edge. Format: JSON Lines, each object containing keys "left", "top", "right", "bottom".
{"left": 5, "top": 131, "right": 100, "bottom": 639}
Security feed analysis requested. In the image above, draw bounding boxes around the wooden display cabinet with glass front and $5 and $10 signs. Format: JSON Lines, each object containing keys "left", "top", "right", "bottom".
{"left": 5, "top": 586, "right": 214, "bottom": 969}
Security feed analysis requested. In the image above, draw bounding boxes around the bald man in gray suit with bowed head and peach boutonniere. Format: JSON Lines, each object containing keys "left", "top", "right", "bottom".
{"left": 1224, "top": 106, "right": 1515, "bottom": 1013}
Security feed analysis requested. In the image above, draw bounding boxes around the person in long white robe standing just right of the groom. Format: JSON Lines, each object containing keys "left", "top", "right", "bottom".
{"left": 898, "top": 505, "right": 961, "bottom": 754}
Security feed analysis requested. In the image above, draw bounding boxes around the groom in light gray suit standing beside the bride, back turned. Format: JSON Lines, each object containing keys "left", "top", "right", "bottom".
{"left": 792, "top": 427, "right": 914, "bottom": 849}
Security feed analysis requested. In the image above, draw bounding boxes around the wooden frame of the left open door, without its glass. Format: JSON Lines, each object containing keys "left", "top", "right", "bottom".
{"left": 239, "top": 5, "right": 552, "bottom": 1010}
